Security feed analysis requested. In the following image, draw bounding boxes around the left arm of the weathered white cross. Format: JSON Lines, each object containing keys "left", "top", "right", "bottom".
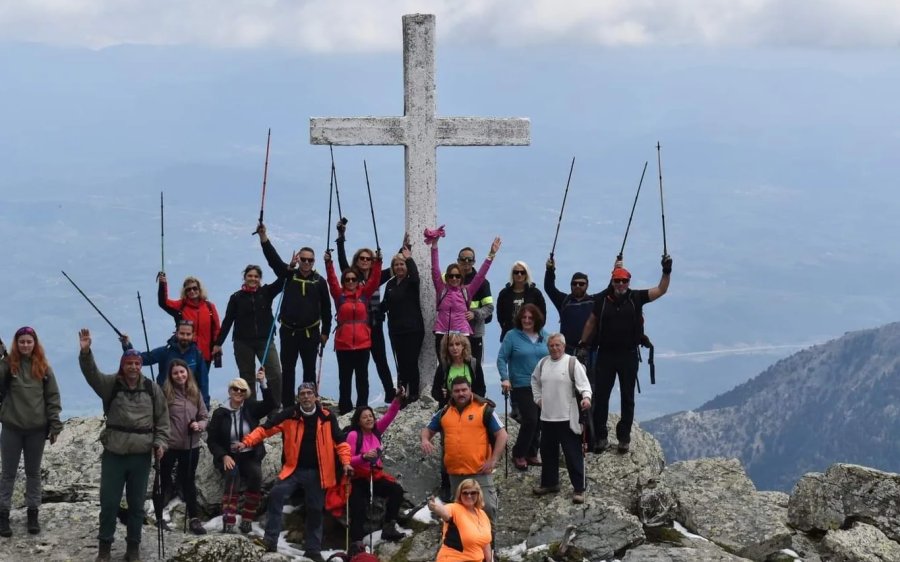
{"left": 309, "top": 117, "right": 406, "bottom": 146}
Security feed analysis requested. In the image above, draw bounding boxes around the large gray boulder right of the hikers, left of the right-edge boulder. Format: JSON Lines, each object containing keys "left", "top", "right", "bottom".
{"left": 661, "top": 459, "right": 792, "bottom": 561}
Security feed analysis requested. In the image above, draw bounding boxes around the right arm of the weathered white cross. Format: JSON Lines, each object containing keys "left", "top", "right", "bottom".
{"left": 435, "top": 117, "right": 531, "bottom": 146}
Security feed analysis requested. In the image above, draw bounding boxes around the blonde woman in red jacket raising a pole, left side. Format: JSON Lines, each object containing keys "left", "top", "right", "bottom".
{"left": 156, "top": 271, "right": 221, "bottom": 370}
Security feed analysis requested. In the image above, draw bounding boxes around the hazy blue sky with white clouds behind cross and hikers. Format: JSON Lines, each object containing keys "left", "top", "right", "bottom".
{"left": 0, "top": 0, "right": 900, "bottom": 419}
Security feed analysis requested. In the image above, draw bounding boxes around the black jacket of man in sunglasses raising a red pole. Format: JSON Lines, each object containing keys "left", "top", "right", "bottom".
{"left": 262, "top": 240, "right": 331, "bottom": 337}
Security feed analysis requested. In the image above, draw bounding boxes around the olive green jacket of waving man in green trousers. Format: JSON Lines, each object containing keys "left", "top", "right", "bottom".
{"left": 78, "top": 351, "right": 169, "bottom": 455}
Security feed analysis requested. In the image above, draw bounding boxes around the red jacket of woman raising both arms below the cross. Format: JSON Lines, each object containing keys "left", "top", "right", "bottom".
{"left": 325, "top": 259, "right": 381, "bottom": 351}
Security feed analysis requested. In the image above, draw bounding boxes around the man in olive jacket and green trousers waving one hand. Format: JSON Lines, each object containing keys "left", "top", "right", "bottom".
{"left": 78, "top": 328, "right": 171, "bottom": 562}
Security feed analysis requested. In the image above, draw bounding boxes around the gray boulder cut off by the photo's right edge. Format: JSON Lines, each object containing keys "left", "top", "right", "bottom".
{"left": 788, "top": 464, "right": 900, "bottom": 541}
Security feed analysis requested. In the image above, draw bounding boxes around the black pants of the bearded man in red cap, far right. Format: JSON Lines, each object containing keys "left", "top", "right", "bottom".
{"left": 593, "top": 349, "right": 640, "bottom": 443}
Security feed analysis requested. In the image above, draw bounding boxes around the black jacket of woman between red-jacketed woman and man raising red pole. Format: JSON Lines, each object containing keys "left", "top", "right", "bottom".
{"left": 216, "top": 278, "right": 284, "bottom": 346}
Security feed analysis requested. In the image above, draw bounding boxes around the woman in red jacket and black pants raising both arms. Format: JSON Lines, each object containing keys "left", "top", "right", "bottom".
{"left": 325, "top": 247, "right": 382, "bottom": 415}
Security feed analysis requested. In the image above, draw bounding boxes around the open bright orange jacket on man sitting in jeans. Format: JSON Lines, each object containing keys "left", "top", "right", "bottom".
{"left": 243, "top": 405, "right": 350, "bottom": 489}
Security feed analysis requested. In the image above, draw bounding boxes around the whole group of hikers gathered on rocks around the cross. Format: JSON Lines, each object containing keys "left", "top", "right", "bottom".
{"left": 0, "top": 221, "right": 672, "bottom": 561}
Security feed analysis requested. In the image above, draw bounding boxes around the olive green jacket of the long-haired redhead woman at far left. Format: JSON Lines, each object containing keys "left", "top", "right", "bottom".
{"left": 0, "top": 357, "right": 63, "bottom": 436}
